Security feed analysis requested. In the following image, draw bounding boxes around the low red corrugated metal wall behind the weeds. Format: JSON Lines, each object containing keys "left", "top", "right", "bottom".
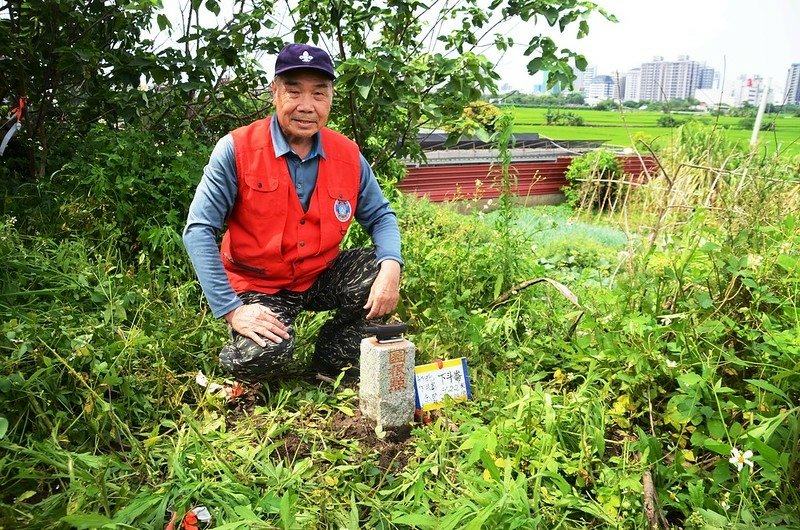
{"left": 398, "top": 156, "right": 656, "bottom": 202}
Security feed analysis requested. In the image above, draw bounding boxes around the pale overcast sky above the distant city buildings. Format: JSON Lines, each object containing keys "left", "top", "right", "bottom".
{"left": 499, "top": 0, "right": 800, "bottom": 90}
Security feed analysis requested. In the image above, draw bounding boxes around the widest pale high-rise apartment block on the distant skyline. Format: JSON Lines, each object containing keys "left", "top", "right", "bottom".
{"left": 639, "top": 55, "right": 700, "bottom": 101}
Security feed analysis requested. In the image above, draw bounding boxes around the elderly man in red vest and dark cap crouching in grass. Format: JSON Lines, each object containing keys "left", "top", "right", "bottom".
{"left": 183, "top": 44, "right": 402, "bottom": 380}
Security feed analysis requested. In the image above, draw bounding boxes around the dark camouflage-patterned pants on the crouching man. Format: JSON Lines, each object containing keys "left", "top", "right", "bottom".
{"left": 219, "top": 249, "right": 378, "bottom": 381}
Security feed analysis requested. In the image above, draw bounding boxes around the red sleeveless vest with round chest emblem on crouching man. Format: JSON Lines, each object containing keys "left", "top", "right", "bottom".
{"left": 225, "top": 118, "right": 361, "bottom": 294}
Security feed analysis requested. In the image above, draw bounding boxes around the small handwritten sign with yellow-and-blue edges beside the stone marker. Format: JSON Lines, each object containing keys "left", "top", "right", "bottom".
{"left": 414, "top": 357, "right": 472, "bottom": 410}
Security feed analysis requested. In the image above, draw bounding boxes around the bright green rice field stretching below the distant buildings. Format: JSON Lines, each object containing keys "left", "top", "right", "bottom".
{"left": 512, "top": 107, "right": 800, "bottom": 156}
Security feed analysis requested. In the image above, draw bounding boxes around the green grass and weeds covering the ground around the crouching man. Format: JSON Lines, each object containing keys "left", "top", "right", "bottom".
{"left": 0, "top": 131, "right": 800, "bottom": 530}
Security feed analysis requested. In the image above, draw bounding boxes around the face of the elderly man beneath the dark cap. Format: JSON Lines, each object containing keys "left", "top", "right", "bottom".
{"left": 272, "top": 70, "right": 333, "bottom": 145}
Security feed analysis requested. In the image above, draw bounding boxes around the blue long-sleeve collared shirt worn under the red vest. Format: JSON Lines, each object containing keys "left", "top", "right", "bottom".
{"left": 183, "top": 117, "right": 403, "bottom": 317}
